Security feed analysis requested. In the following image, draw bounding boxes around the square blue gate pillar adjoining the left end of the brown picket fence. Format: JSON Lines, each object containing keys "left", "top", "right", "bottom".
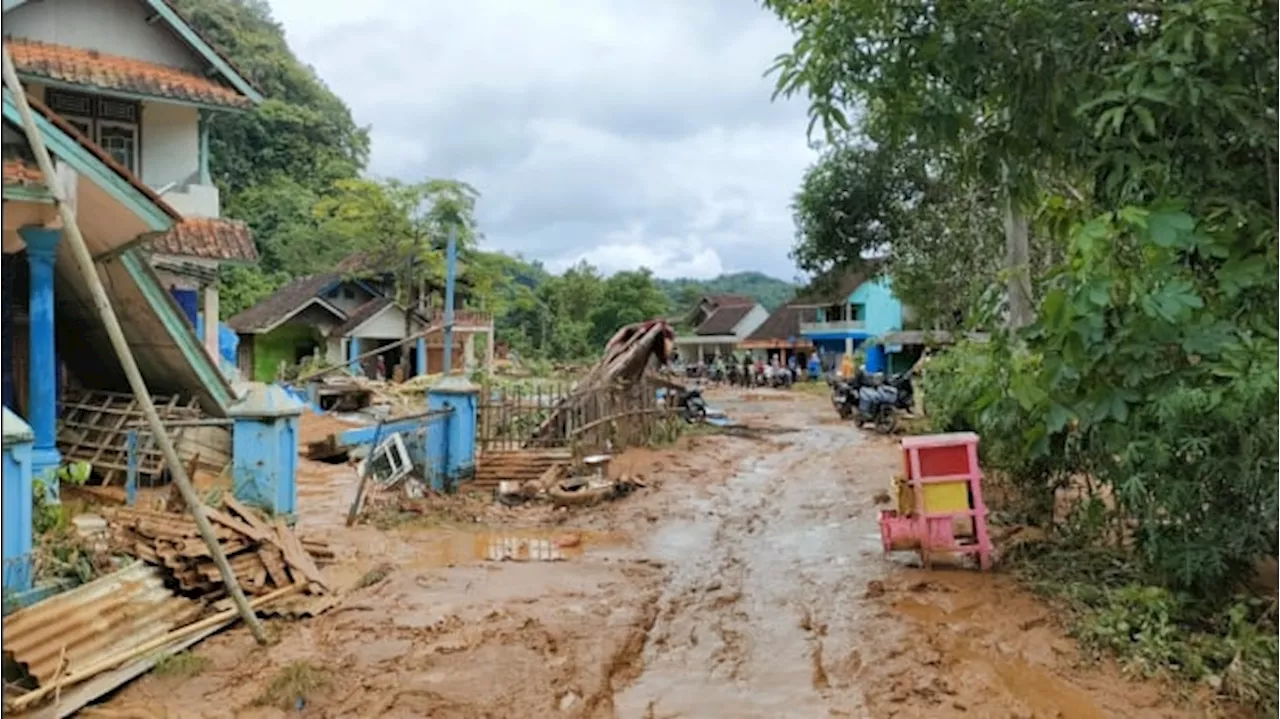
{"left": 426, "top": 375, "right": 480, "bottom": 491}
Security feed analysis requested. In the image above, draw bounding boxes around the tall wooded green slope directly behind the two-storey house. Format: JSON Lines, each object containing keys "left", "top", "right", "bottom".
{"left": 172, "top": 0, "right": 369, "bottom": 313}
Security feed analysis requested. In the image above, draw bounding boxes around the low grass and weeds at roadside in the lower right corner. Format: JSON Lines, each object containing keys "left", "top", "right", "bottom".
{"left": 1010, "top": 541, "right": 1280, "bottom": 716}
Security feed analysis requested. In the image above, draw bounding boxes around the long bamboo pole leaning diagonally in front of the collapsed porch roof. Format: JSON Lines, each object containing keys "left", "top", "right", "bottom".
{"left": 0, "top": 42, "right": 268, "bottom": 645}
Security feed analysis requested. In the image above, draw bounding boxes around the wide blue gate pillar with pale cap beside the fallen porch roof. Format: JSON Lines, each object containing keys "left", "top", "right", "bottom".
{"left": 227, "top": 383, "right": 305, "bottom": 518}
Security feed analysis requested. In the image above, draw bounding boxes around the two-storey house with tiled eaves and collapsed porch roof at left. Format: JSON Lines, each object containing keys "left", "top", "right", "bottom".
{"left": 3, "top": 0, "right": 261, "bottom": 583}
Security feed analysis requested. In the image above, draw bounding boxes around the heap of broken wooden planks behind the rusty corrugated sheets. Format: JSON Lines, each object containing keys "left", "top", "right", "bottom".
{"left": 105, "top": 498, "right": 333, "bottom": 597}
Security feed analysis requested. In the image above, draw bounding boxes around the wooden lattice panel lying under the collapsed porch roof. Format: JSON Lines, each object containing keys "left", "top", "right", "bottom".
{"left": 58, "top": 391, "right": 201, "bottom": 485}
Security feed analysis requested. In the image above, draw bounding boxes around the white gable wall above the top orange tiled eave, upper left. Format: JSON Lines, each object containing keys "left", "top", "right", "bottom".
{"left": 4, "top": 0, "right": 204, "bottom": 72}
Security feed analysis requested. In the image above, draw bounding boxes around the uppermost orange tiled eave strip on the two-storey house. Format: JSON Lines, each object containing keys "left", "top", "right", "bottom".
{"left": 5, "top": 38, "right": 252, "bottom": 107}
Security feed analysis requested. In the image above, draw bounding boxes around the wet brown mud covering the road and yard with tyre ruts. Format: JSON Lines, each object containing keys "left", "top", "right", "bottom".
{"left": 99, "top": 391, "right": 1218, "bottom": 719}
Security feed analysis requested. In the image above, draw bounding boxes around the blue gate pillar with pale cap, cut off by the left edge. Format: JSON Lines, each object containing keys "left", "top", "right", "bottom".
{"left": 0, "top": 407, "right": 35, "bottom": 592}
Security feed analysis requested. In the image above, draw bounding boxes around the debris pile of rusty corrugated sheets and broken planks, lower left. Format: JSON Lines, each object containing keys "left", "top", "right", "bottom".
{"left": 4, "top": 498, "right": 339, "bottom": 719}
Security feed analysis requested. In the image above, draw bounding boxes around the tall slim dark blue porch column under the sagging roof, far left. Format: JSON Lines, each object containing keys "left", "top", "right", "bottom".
{"left": 18, "top": 228, "right": 63, "bottom": 488}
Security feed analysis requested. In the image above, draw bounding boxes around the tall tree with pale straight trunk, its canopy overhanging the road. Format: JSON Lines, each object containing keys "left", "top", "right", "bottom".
{"left": 764, "top": 0, "right": 1134, "bottom": 328}
